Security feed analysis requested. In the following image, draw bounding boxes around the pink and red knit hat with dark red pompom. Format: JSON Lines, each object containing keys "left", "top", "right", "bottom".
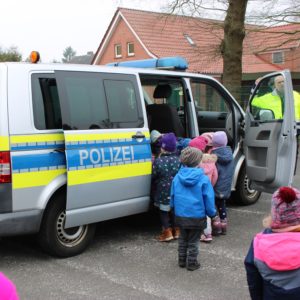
{"left": 271, "top": 186, "right": 300, "bottom": 230}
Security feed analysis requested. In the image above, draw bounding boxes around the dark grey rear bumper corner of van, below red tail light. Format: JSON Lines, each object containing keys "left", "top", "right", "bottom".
{"left": 0, "top": 209, "right": 43, "bottom": 236}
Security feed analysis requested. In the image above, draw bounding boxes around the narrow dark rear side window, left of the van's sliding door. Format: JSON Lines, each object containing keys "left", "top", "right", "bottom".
{"left": 32, "top": 74, "right": 62, "bottom": 130}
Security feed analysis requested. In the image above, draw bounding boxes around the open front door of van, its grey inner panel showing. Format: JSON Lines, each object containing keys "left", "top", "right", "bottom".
{"left": 244, "top": 70, "right": 297, "bottom": 193}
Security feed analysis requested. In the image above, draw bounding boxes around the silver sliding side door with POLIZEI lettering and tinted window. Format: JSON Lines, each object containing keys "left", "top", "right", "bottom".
{"left": 55, "top": 71, "right": 152, "bottom": 228}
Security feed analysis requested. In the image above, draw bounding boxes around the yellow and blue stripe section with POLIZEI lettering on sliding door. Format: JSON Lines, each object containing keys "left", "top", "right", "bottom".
{"left": 65, "top": 131, "right": 152, "bottom": 186}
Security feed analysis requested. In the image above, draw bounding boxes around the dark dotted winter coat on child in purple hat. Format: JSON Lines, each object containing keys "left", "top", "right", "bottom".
{"left": 152, "top": 152, "right": 180, "bottom": 211}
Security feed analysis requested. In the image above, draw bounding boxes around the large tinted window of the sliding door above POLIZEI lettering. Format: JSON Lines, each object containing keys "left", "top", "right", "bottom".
{"left": 56, "top": 71, "right": 144, "bottom": 130}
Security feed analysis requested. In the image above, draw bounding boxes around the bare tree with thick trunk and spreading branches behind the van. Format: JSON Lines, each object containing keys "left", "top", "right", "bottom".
{"left": 169, "top": 0, "right": 300, "bottom": 99}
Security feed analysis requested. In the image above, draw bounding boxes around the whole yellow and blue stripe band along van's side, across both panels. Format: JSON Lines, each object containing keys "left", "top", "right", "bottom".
{"left": 11, "top": 132, "right": 151, "bottom": 189}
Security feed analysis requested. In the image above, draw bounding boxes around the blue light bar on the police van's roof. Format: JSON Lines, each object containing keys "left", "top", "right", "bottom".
{"left": 107, "top": 56, "right": 188, "bottom": 71}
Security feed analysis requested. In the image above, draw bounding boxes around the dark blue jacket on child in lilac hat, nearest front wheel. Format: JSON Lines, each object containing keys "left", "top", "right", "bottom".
{"left": 211, "top": 146, "right": 234, "bottom": 199}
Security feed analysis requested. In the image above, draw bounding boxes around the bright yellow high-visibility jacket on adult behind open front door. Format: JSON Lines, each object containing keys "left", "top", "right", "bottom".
{"left": 251, "top": 91, "right": 300, "bottom": 120}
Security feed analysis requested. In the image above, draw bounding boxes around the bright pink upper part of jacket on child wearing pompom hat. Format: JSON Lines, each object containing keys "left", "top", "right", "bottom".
{"left": 253, "top": 232, "right": 300, "bottom": 271}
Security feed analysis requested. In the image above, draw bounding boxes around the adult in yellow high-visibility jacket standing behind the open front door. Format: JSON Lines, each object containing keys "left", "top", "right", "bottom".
{"left": 251, "top": 75, "right": 300, "bottom": 121}
